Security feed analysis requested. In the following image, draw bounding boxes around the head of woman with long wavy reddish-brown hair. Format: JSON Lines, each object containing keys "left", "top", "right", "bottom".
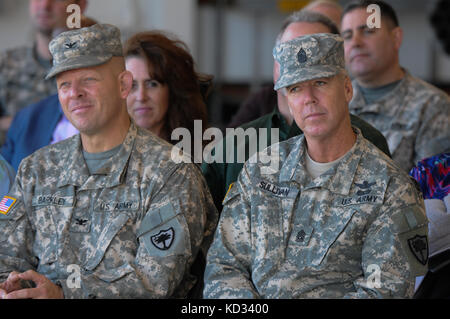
{"left": 124, "top": 31, "right": 212, "bottom": 151}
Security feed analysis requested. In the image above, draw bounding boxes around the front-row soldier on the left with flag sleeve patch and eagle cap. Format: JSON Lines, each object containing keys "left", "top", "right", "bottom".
{"left": 0, "top": 25, "right": 218, "bottom": 298}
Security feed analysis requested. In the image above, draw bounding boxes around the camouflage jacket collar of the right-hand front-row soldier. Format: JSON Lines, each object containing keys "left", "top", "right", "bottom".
{"left": 280, "top": 127, "right": 365, "bottom": 195}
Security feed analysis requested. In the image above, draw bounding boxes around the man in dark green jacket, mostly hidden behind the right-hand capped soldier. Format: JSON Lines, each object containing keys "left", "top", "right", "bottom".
{"left": 200, "top": 11, "right": 390, "bottom": 211}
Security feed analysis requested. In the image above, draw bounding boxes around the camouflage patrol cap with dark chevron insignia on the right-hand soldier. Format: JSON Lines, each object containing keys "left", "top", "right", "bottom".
{"left": 273, "top": 33, "right": 345, "bottom": 90}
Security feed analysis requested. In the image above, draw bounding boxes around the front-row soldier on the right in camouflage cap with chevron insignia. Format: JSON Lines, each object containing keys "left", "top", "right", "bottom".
{"left": 204, "top": 34, "right": 428, "bottom": 298}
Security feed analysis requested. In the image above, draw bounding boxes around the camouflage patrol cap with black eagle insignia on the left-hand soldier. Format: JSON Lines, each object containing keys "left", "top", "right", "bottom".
{"left": 46, "top": 24, "right": 123, "bottom": 79}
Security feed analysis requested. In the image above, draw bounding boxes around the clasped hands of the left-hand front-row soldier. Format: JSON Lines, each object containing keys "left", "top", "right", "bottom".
{"left": 0, "top": 270, "right": 64, "bottom": 299}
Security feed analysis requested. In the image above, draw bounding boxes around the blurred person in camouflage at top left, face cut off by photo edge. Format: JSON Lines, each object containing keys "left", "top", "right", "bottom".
{"left": 0, "top": 0, "right": 87, "bottom": 145}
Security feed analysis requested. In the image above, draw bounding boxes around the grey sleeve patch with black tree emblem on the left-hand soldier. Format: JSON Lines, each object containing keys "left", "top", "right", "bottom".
{"left": 137, "top": 203, "right": 190, "bottom": 257}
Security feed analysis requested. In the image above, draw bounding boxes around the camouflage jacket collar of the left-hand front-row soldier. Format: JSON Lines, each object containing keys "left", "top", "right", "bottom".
{"left": 58, "top": 122, "right": 137, "bottom": 190}
